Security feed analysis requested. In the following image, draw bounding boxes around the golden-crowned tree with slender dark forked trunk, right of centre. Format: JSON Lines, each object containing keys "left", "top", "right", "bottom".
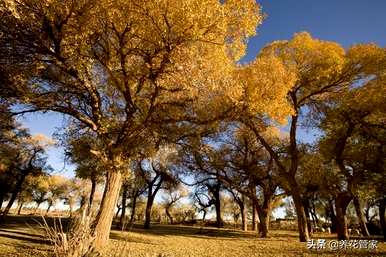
{"left": 240, "top": 32, "right": 384, "bottom": 241}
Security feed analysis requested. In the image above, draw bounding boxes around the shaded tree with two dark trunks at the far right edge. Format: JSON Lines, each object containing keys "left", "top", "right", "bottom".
{"left": 320, "top": 73, "right": 386, "bottom": 239}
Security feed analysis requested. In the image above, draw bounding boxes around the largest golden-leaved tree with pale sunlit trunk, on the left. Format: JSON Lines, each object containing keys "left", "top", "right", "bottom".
{"left": 0, "top": 0, "right": 262, "bottom": 250}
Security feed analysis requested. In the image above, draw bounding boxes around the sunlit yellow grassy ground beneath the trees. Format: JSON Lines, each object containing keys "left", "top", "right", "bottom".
{"left": 0, "top": 214, "right": 386, "bottom": 257}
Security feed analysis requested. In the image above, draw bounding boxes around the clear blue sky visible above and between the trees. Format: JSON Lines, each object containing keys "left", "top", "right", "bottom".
{"left": 21, "top": 0, "right": 386, "bottom": 174}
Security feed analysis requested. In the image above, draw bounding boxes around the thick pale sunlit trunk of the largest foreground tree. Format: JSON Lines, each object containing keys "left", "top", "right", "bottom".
{"left": 94, "top": 170, "right": 122, "bottom": 252}
